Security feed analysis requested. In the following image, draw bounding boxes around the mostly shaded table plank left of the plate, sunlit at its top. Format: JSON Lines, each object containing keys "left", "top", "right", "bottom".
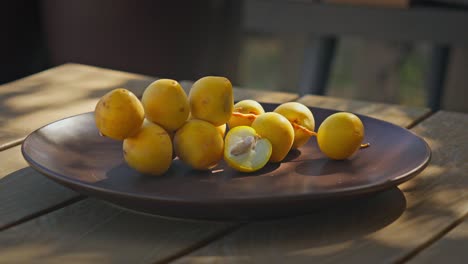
{"left": 0, "top": 146, "right": 79, "bottom": 230}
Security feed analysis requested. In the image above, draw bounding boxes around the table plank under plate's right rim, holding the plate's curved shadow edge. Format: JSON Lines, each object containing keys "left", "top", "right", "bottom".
{"left": 173, "top": 112, "right": 468, "bottom": 263}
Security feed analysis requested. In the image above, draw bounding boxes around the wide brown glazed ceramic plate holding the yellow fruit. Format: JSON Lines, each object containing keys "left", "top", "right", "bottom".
{"left": 22, "top": 104, "right": 431, "bottom": 219}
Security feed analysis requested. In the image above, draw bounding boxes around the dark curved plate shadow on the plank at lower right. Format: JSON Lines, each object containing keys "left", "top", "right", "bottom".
{"left": 176, "top": 187, "right": 406, "bottom": 263}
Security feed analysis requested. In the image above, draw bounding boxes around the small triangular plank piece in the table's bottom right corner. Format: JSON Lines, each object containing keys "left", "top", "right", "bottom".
{"left": 409, "top": 219, "right": 468, "bottom": 264}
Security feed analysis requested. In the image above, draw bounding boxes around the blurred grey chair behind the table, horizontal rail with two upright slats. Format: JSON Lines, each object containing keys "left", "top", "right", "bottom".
{"left": 244, "top": 0, "right": 468, "bottom": 111}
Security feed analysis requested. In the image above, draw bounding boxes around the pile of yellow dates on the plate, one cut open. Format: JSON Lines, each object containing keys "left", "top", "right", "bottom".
{"left": 95, "top": 76, "right": 364, "bottom": 175}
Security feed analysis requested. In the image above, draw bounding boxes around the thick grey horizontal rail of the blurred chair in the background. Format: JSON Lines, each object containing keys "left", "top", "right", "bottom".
{"left": 243, "top": 0, "right": 468, "bottom": 43}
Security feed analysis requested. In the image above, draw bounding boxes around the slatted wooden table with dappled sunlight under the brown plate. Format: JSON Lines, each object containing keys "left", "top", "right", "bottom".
{"left": 0, "top": 64, "right": 468, "bottom": 263}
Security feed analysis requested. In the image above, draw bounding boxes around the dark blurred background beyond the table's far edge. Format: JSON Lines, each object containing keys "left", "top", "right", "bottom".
{"left": 0, "top": 0, "right": 468, "bottom": 112}
